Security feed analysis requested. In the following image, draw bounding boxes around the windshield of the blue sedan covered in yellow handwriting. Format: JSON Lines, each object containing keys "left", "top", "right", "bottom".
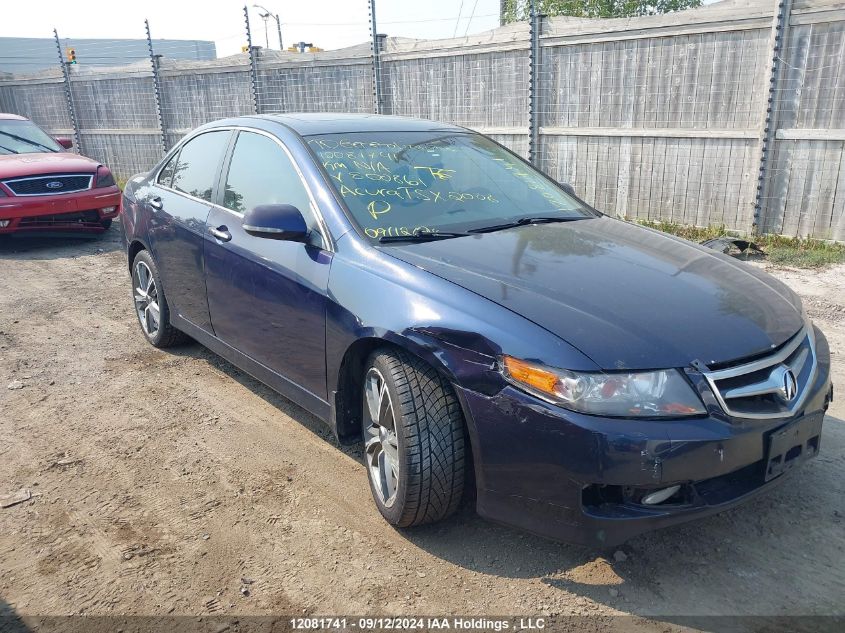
{"left": 307, "top": 131, "right": 595, "bottom": 241}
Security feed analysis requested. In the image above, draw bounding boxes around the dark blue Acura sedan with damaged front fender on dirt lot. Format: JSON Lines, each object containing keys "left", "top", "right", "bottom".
{"left": 122, "top": 114, "right": 833, "bottom": 545}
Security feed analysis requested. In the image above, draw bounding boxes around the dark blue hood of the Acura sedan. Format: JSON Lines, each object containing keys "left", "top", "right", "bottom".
{"left": 382, "top": 217, "right": 803, "bottom": 369}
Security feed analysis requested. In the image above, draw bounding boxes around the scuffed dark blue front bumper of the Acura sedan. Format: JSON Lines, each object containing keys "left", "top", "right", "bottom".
{"left": 458, "top": 330, "right": 832, "bottom": 546}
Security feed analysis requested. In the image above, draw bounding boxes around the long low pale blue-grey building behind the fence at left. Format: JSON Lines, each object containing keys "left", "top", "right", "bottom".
{"left": 0, "top": 37, "right": 217, "bottom": 73}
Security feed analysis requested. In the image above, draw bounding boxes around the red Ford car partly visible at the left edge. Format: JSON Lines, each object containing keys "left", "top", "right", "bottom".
{"left": 0, "top": 113, "right": 120, "bottom": 235}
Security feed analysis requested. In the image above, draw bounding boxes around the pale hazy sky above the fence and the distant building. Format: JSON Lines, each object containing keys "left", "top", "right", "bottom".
{"left": 0, "top": 0, "right": 499, "bottom": 57}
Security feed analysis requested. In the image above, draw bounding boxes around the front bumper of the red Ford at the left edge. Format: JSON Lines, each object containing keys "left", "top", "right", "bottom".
{"left": 0, "top": 186, "right": 120, "bottom": 234}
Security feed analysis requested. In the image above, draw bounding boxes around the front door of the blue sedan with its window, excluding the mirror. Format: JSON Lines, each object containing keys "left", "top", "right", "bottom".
{"left": 205, "top": 131, "right": 331, "bottom": 400}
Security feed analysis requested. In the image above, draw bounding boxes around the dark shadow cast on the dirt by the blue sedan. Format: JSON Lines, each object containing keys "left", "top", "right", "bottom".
{"left": 155, "top": 330, "right": 845, "bottom": 631}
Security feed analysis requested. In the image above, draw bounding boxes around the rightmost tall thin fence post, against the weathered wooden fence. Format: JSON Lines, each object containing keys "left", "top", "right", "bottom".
{"left": 751, "top": 0, "right": 792, "bottom": 235}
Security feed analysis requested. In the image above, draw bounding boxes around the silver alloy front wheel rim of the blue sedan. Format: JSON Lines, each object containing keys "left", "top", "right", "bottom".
{"left": 364, "top": 367, "right": 399, "bottom": 508}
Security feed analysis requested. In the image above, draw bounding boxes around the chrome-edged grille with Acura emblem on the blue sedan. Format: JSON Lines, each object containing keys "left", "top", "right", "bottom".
{"left": 703, "top": 325, "right": 817, "bottom": 419}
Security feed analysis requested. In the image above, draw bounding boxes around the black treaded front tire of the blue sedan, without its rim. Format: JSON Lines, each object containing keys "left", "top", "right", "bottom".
{"left": 362, "top": 349, "right": 466, "bottom": 527}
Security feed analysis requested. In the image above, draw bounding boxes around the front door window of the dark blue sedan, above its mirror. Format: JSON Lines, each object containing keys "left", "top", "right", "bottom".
{"left": 223, "top": 132, "right": 317, "bottom": 229}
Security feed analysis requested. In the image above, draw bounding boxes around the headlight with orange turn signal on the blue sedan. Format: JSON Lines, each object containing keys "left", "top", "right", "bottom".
{"left": 500, "top": 356, "right": 705, "bottom": 417}
